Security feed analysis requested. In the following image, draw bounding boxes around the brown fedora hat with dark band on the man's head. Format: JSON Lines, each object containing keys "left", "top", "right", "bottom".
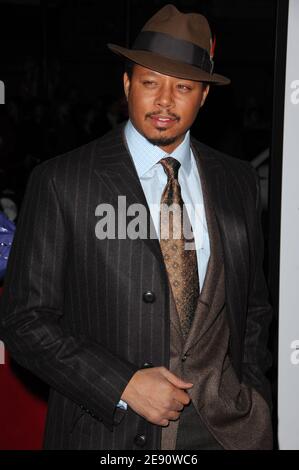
{"left": 108, "top": 5, "right": 230, "bottom": 85}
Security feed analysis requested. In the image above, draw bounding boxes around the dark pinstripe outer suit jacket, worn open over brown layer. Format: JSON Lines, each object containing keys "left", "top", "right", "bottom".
{"left": 0, "top": 127, "right": 271, "bottom": 449}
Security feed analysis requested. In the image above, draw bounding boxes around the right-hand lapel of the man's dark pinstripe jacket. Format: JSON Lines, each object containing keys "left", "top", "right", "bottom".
{"left": 192, "top": 142, "right": 249, "bottom": 342}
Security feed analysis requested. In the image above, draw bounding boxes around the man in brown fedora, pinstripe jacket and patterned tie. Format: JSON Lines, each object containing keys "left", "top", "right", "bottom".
{"left": 1, "top": 5, "right": 272, "bottom": 450}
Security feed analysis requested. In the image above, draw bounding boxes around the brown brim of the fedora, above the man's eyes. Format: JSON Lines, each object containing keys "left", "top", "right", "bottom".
{"left": 107, "top": 44, "right": 230, "bottom": 85}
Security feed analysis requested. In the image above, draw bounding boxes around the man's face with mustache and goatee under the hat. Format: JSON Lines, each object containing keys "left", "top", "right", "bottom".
{"left": 124, "top": 65, "right": 209, "bottom": 153}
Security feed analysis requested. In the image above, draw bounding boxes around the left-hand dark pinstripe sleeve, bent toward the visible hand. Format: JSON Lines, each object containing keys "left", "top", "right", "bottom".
{"left": 0, "top": 162, "right": 138, "bottom": 429}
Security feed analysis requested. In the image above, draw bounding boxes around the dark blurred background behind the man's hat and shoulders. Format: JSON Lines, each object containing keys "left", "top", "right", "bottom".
{"left": 0, "top": 0, "right": 277, "bottom": 448}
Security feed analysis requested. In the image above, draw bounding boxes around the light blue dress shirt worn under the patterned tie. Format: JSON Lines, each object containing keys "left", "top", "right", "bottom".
{"left": 117, "top": 120, "right": 210, "bottom": 409}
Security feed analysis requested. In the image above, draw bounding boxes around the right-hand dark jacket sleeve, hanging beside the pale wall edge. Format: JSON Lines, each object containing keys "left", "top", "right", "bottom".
{"left": 242, "top": 167, "right": 272, "bottom": 408}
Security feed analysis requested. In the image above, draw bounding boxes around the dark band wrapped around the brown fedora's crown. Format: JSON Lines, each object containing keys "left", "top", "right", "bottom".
{"left": 133, "top": 31, "right": 213, "bottom": 73}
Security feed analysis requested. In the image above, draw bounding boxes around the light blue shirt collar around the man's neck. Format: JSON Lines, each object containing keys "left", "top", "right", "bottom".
{"left": 125, "top": 120, "right": 191, "bottom": 178}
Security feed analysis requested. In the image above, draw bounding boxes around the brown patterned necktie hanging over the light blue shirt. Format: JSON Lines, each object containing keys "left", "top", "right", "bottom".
{"left": 159, "top": 157, "right": 199, "bottom": 338}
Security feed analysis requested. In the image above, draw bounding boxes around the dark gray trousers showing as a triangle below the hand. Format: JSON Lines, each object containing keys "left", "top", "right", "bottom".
{"left": 175, "top": 402, "right": 224, "bottom": 450}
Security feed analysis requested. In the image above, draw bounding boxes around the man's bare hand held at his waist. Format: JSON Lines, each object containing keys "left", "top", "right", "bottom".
{"left": 121, "top": 367, "right": 193, "bottom": 426}
